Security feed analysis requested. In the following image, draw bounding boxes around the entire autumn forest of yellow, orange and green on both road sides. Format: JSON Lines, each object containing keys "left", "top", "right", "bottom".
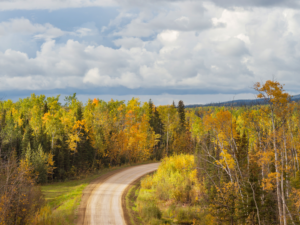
{"left": 0, "top": 80, "right": 300, "bottom": 225}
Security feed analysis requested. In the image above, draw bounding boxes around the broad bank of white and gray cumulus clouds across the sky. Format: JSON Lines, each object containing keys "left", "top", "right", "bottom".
{"left": 0, "top": 1, "right": 300, "bottom": 99}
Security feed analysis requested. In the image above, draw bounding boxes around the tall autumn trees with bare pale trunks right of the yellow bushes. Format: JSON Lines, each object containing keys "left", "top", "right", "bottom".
{"left": 191, "top": 81, "right": 300, "bottom": 225}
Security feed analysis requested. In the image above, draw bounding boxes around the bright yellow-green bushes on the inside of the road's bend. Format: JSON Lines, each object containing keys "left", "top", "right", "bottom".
{"left": 137, "top": 155, "right": 216, "bottom": 225}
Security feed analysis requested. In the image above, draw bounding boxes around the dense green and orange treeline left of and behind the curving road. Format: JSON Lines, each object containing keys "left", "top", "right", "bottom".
{"left": 0, "top": 94, "right": 189, "bottom": 183}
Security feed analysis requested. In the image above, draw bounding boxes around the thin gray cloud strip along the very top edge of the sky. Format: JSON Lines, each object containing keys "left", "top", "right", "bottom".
{"left": 0, "top": 0, "right": 300, "bottom": 11}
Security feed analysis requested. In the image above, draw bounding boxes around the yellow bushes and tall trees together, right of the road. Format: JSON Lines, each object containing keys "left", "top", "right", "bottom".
{"left": 137, "top": 81, "right": 300, "bottom": 225}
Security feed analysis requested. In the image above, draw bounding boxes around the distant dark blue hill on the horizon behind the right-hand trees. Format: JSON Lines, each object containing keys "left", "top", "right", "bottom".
{"left": 185, "top": 95, "right": 300, "bottom": 108}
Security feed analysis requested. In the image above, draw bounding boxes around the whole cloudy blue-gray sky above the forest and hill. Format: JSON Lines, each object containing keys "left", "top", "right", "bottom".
{"left": 0, "top": 0, "right": 300, "bottom": 105}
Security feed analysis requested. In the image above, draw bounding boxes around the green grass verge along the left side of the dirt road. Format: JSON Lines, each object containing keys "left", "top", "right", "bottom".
{"left": 31, "top": 161, "right": 157, "bottom": 225}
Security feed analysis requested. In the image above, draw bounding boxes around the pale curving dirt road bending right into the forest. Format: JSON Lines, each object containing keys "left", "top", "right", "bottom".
{"left": 81, "top": 163, "right": 159, "bottom": 225}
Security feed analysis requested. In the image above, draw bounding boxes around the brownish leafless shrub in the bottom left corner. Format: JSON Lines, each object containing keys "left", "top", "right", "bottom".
{"left": 0, "top": 153, "right": 43, "bottom": 225}
